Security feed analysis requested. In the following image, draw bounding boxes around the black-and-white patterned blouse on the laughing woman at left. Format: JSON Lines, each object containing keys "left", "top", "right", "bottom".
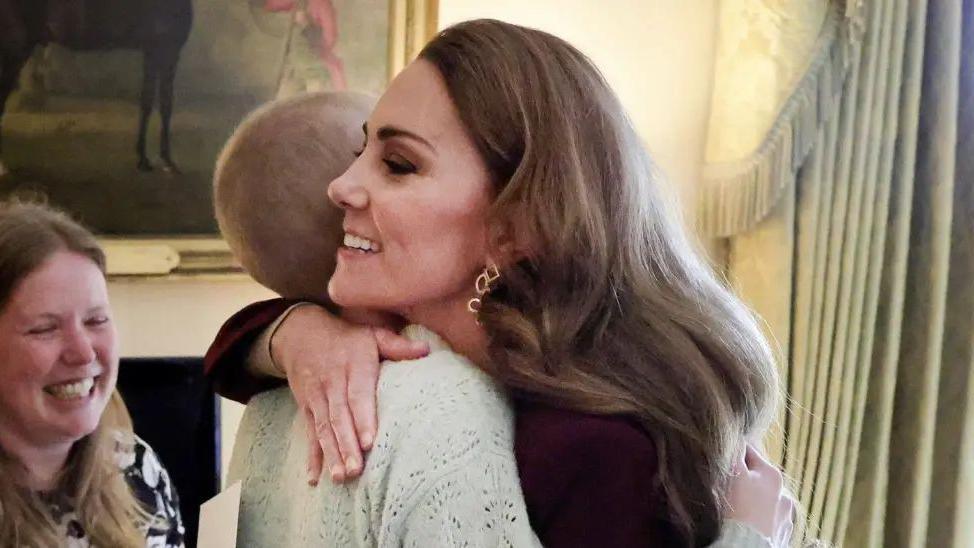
{"left": 41, "top": 433, "right": 185, "bottom": 548}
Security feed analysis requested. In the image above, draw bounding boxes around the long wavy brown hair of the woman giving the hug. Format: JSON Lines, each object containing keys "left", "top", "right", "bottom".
{"left": 420, "top": 20, "right": 778, "bottom": 545}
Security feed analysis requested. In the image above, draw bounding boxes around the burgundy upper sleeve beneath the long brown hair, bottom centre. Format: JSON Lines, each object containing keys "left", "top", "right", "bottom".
{"left": 515, "top": 406, "right": 680, "bottom": 548}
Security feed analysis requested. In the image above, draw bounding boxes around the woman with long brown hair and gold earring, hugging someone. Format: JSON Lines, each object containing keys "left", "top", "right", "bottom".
{"left": 210, "top": 21, "right": 787, "bottom": 546}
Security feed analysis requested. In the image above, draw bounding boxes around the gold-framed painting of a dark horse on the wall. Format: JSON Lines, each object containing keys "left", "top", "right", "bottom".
{"left": 0, "top": 0, "right": 436, "bottom": 275}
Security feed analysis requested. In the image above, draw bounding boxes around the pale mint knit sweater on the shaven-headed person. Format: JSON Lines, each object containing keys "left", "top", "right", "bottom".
{"left": 228, "top": 326, "right": 768, "bottom": 548}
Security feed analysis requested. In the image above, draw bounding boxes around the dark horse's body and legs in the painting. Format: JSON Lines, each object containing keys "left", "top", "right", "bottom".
{"left": 0, "top": 0, "right": 193, "bottom": 174}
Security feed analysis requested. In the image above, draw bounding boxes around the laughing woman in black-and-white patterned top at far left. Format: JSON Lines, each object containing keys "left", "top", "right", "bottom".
{"left": 0, "top": 201, "right": 184, "bottom": 548}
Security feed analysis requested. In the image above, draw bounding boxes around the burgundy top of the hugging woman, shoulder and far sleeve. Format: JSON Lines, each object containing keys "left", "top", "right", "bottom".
{"left": 205, "top": 299, "right": 681, "bottom": 548}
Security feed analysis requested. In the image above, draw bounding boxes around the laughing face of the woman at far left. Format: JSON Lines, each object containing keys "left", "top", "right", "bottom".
{"left": 0, "top": 251, "right": 118, "bottom": 445}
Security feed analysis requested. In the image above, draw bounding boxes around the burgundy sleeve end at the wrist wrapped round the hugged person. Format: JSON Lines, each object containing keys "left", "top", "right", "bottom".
{"left": 203, "top": 299, "right": 298, "bottom": 403}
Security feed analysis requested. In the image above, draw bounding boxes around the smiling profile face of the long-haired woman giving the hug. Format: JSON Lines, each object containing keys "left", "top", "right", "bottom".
{"left": 328, "top": 60, "right": 492, "bottom": 317}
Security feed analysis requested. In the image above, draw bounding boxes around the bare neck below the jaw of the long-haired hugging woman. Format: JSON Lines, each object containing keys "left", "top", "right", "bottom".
{"left": 403, "top": 295, "right": 488, "bottom": 367}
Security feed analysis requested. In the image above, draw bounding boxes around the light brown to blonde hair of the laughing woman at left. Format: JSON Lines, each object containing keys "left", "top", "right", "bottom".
{"left": 0, "top": 200, "right": 148, "bottom": 548}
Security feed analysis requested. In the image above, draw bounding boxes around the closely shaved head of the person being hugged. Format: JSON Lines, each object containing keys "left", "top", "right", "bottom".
{"left": 213, "top": 92, "right": 375, "bottom": 303}
